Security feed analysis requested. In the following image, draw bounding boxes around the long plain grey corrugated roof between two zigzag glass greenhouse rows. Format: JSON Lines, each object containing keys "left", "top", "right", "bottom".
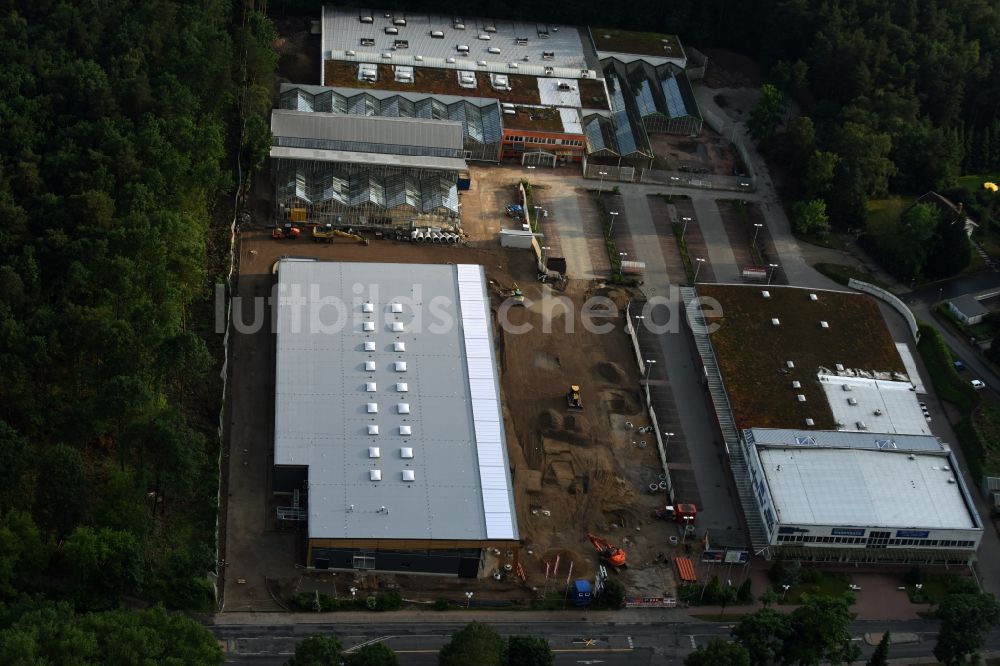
{"left": 271, "top": 109, "right": 462, "bottom": 150}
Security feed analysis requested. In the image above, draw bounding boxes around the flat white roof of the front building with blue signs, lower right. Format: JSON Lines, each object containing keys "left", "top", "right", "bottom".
{"left": 757, "top": 447, "right": 979, "bottom": 529}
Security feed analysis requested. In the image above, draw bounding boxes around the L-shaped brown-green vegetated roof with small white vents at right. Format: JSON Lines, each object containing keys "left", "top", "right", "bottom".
{"left": 698, "top": 284, "right": 905, "bottom": 430}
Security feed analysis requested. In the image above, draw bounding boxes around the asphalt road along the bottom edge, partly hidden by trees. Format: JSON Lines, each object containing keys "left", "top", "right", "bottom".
{"left": 211, "top": 615, "right": 1000, "bottom": 666}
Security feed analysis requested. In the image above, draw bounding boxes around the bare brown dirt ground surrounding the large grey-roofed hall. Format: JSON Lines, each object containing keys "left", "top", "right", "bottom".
{"left": 225, "top": 229, "right": 676, "bottom": 610}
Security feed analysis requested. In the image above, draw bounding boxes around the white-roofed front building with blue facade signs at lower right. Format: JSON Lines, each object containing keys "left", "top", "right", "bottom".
{"left": 740, "top": 428, "right": 983, "bottom": 564}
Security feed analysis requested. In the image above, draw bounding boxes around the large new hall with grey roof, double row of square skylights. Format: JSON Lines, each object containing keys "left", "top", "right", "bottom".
{"left": 273, "top": 259, "right": 518, "bottom": 577}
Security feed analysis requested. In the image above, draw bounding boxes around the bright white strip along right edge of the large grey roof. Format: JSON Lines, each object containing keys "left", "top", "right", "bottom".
{"left": 456, "top": 264, "right": 517, "bottom": 539}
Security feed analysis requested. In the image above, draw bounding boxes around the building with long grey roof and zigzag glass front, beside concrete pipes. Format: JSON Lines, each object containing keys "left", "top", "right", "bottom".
{"left": 271, "top": 109, "right": 466, "bottom": 228}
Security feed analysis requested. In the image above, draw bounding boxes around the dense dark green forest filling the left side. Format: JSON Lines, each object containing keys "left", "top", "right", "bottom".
{"left": 0, "top": 0, "right": 275, "bottom": 652}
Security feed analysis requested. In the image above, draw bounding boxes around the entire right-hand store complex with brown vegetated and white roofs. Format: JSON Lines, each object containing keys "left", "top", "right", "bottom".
{"left": 682, "top": 284, "right": 983, "bottom": 564}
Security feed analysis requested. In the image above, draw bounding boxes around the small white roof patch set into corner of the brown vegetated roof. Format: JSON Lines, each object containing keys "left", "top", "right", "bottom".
{"left": 818, "top": 373, "right": 932, "bottom": 435}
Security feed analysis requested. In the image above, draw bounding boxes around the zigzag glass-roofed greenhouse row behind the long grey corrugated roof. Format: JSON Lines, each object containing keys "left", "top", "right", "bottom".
{"left": 279, "top": 83, "right": 503, "bottom": 162}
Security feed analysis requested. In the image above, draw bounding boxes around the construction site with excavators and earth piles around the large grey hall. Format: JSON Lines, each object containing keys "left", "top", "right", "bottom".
{"left": 229, "top": 228, "right": 698, "bottom": 603}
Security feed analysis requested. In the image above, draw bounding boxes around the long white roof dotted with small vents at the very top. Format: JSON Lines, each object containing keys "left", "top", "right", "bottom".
{"left": 321, "top": 6, "right": 593, "bottom": 77}
